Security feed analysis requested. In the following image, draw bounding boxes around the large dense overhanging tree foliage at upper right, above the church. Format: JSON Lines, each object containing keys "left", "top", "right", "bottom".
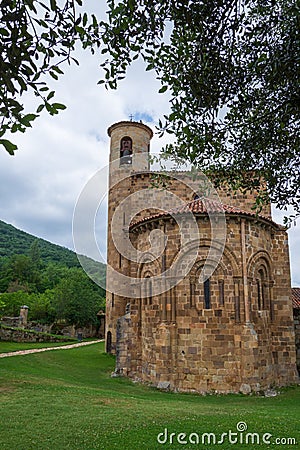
{"left": 102, "top": 0, "right": 300, "bottom": 212}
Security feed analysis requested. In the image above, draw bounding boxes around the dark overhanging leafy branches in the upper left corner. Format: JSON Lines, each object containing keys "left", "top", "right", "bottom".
{"left": 0, "top": 0, "right": 99, "bottom": 154}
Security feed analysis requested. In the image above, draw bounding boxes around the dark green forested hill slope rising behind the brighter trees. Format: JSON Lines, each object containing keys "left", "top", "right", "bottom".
{"left": 0, "top": 220, "right": 106, "bottom": 280}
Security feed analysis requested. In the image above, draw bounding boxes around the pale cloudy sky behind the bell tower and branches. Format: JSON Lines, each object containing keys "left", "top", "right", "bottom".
{"left": 0, "top": 0, "right": 300, "bottom": 286}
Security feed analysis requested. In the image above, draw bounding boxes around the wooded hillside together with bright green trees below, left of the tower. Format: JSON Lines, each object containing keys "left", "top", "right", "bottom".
{"left": 0, "top": 222, "right": 105, "bottom": 326}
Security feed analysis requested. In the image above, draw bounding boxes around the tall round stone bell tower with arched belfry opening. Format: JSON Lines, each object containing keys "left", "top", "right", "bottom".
{"left": 106, "top": 121, "right": 153, "bottom": 353}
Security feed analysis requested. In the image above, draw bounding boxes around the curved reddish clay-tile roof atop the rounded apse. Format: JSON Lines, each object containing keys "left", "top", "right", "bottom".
{"left": 131, "top": 198, "right": 277, "bottom": 227}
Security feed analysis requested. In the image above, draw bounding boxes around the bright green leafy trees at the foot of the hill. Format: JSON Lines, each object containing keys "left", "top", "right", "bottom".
{"left": 0, "top": 255, "right": 105, "bottom": 326}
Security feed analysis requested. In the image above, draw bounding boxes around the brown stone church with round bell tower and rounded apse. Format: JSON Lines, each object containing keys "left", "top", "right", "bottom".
{"left": 106, "top": 121, "right": 298, "bottom": 393}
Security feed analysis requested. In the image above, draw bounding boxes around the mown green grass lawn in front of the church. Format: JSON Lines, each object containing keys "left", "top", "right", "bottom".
{"left": 0, "top": 343, "right": 300, "bottom": 450}
